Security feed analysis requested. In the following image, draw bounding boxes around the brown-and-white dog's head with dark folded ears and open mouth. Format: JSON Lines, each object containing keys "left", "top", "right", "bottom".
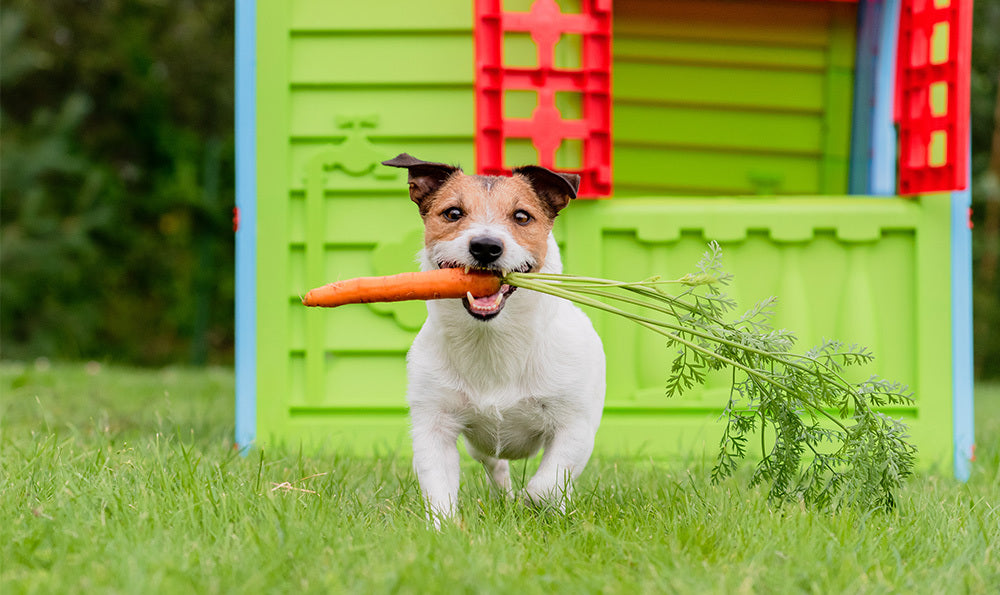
{"left": 382, "top": 153, "right": 580, "bottom": 320}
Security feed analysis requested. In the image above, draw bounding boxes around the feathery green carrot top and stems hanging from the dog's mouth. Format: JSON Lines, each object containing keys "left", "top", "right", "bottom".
{"left": 505, "top": 242, "right": 915, "bottom": 510}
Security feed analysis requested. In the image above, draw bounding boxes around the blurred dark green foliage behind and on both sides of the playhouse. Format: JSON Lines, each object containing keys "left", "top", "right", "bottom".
{"left": 0, "top": 0, "right": 1000, "bottom": 377}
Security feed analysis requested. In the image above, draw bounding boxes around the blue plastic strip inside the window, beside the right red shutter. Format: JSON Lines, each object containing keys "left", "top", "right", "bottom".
{"left": 867, "top": 0, "right": 901, "bottom": 196}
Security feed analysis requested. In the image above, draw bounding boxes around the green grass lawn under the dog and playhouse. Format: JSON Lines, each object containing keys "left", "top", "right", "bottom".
{"left": 0, "top": 363, "right": 1000, "bottom": 595}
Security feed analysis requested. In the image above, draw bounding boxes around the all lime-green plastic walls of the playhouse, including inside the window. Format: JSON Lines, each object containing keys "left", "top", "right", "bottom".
{"left": 250, "top": 0, "right": 951, "bottom": 464}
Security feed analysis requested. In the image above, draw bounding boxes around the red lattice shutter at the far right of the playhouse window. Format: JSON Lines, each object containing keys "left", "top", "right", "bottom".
{"left": 896, "top": 0, "right": 972, "bottom": 194}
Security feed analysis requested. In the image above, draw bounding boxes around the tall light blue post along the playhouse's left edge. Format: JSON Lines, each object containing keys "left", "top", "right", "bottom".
{"left": 235, "top": 0, "right": 257, "bottom": 454}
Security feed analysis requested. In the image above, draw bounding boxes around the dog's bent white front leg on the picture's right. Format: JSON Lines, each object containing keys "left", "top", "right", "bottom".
{"left": 524, "top": 423, "right": 595, "bottom": 512}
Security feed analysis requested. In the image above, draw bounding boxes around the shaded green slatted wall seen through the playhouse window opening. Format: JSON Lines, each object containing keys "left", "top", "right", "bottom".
{"left": 613, "top": 0, "right": 857, "bottom": 196}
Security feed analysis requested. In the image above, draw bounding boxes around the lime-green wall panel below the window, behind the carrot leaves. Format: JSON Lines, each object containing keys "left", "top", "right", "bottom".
{"left": 561, "top": 195, "right": 952, "bottom": 464}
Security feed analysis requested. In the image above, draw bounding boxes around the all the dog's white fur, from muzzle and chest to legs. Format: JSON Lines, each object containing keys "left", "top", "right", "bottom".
{"left": 407, "top": 209, "right": 605, "bottom": 526}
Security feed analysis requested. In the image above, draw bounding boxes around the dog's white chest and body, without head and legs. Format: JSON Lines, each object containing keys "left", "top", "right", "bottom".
{"left": 407, "top": 294, "right": 604, "bottom": 459}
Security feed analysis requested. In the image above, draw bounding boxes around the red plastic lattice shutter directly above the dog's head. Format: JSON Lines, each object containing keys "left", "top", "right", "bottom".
{"left": 475, "top": 0, "right": 611, "bottom": 197}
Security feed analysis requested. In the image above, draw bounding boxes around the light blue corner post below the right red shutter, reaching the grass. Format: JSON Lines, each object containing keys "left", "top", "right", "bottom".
{"left": 951, "top": 161, "right": 975, "bottom": 481}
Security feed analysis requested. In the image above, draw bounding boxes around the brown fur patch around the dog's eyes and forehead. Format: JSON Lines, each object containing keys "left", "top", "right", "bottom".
{"left": 423, "top": 173, "right": 557, "bottom": 271}
